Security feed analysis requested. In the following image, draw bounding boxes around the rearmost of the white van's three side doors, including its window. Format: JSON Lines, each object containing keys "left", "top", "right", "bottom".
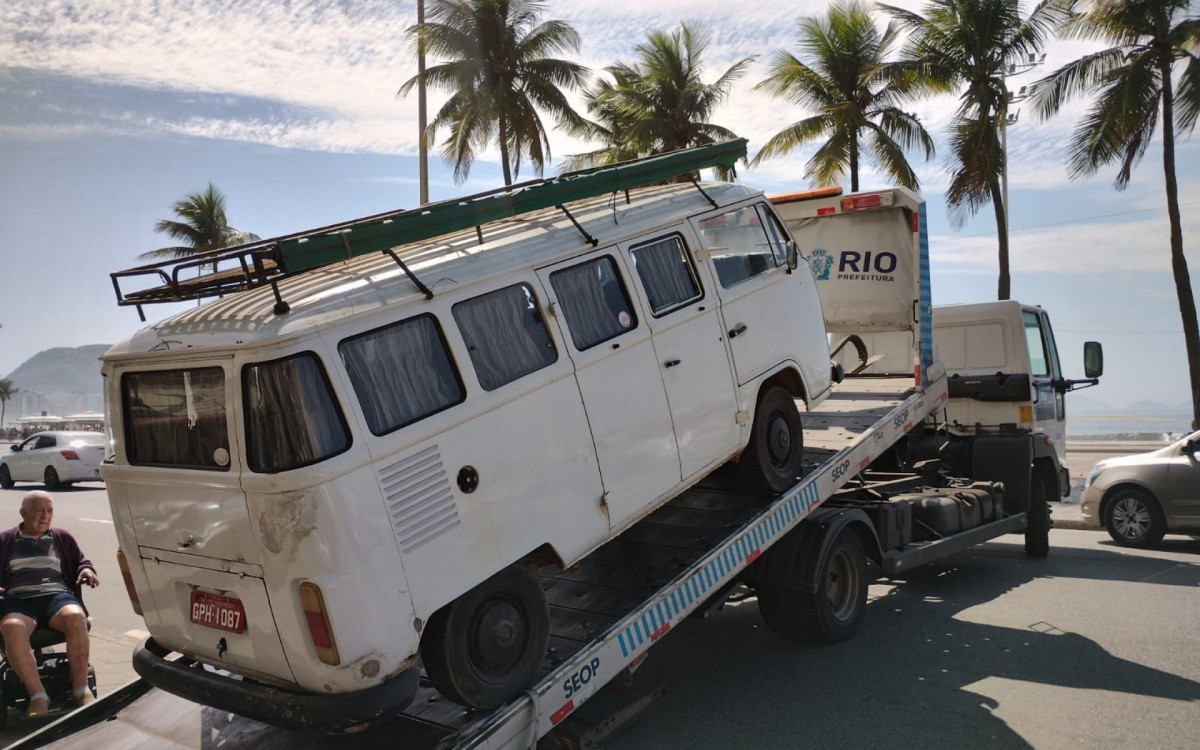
{"left": 538, "top": 250, "right": 680, "bottom": 528}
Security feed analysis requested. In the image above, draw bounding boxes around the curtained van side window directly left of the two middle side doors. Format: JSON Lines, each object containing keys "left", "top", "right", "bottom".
{"left": 452, "top": 284, "right": 558, "bottom": 390}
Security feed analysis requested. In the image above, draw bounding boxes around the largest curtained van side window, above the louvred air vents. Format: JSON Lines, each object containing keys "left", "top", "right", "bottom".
{"left": 337, "top": 316, "right": 464, "bottom": 434}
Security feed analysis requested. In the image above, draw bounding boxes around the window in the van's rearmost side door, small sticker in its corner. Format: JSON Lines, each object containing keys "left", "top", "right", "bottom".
{"left": 550, "top": 256, "right": 637, "bottom": 352}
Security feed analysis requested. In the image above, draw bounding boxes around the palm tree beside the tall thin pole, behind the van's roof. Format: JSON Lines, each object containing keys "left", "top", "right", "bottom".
{"left": 400, "top": 0, "right": 587, "bottom": 186}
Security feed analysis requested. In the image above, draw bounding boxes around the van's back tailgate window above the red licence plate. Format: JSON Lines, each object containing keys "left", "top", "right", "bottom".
{"left": 121, "top": 367, "right": 229, "bottom": 472}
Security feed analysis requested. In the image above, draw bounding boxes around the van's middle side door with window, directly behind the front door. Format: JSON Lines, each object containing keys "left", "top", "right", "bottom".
{"left": 626, "top": 234, "right": 740, "bottom": 479}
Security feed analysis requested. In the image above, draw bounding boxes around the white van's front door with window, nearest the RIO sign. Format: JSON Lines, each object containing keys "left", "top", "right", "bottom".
{"left": 698, "top": 206, "right": 811, "bottom": 385}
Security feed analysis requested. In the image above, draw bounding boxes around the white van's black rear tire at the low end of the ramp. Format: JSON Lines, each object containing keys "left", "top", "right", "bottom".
{"left": 421, "top": 565, "right": 550, "bottom": 709}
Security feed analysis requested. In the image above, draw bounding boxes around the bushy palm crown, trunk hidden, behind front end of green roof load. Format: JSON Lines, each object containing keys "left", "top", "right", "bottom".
{"left": 566, "top": 23, "right": 756, "bottom": 177}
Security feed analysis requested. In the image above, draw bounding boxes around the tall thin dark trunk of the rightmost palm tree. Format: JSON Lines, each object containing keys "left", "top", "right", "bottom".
{"left": 1158, "top": 54, "right": 1200, "bottom": 427}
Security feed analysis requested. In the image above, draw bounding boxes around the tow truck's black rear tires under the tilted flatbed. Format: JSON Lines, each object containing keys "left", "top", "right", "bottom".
{"left": 758, "top": 529, "right": 870, "bottom": 643}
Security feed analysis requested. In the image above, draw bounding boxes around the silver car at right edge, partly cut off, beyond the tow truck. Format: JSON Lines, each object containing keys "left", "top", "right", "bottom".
{"left": 1080, "top": 432, "right": 1200, "bottom": 547}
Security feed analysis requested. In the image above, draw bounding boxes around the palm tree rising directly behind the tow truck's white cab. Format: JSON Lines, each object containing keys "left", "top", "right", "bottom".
{"left": 881, "top": 0, "right": 1066, "bottom": 300}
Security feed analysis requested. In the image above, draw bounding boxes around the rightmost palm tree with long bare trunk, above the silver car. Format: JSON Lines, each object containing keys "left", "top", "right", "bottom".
{"left": 1033, "top": 0, "right": 1200, "bottom": 422}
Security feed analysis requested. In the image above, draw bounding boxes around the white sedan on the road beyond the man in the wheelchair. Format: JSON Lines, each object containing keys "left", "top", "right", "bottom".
{"left": 0, "top": 432, "right": 104, "bottom": 491}
